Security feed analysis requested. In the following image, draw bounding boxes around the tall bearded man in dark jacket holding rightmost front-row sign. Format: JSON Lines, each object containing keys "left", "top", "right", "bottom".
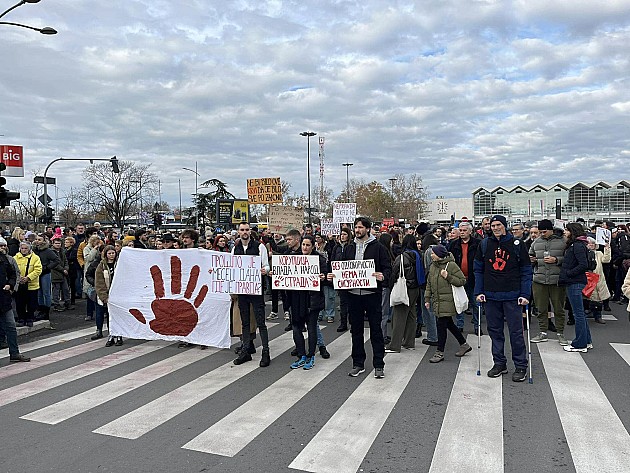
{"left": 328, "top": 217, "right": 392, "bottom": 379}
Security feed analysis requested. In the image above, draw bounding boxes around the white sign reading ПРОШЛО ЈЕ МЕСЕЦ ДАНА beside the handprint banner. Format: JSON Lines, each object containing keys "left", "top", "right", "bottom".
{"left": 208, "top": 251, "right": 262, "bottom": 295}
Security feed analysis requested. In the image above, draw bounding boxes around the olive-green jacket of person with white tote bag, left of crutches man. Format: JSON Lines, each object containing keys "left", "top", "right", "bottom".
{"left": 424, "top": 253, "right": 466, "bottom": 317}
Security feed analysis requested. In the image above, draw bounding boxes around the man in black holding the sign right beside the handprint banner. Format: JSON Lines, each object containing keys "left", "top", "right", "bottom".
{"left": 232, "top": 222, "right": 271, "bottom": 368}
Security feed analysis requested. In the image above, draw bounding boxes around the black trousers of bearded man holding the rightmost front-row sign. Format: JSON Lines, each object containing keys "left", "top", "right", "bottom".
{"left": 348, "top": 291, "right": 385, "bottom": 368}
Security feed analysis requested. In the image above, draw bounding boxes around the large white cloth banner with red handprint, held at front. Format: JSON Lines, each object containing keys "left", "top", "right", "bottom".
{"left": 107, "top": 248, "right": 235, "bottom": 348}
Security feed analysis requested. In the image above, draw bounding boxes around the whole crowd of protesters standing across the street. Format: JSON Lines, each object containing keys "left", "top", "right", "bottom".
{"left": 0, "top": 215, "right": 630, "bottom": 381}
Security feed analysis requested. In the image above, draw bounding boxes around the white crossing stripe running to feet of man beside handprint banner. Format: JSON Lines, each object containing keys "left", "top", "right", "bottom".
{"left": 94, "top": 332, "right": 293, "bottom": 439}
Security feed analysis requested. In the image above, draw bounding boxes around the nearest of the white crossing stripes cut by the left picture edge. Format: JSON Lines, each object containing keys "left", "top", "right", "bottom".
{"left": 0, "top": 341, "right": 170, "bottom": 406}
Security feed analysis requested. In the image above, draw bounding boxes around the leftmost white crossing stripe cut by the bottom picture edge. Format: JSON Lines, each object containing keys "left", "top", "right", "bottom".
{"left": 289, "top": 345, "right": 427, "bottom": 473}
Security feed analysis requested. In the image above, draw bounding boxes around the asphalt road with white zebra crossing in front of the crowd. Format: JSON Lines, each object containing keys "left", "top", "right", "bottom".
{"left": 0, "top": 296, "right": 630, "bottom": 473}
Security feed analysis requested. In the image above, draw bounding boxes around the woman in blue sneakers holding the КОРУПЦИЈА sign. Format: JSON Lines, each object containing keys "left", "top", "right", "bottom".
{"left": 286, "top": 235, "right": 330, "bottom": 370}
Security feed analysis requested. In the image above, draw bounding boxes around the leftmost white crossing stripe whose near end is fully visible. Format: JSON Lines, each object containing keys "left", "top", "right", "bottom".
{"left": 21, "top": 342, "right": 220, "bottom": 425}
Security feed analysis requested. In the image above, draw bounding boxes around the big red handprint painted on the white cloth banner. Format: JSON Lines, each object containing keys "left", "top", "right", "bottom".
{"left": 129, "top": 256, "right": 208, "bottom": 336}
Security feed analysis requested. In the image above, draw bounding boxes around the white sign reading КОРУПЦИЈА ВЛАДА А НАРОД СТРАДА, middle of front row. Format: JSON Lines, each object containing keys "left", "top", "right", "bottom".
{"left": 271, "top": 255, "right": 321, "bottom": 291}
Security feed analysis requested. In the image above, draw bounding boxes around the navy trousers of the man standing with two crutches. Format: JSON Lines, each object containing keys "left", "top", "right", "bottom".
{"left": 485, "top": 301, "right": 527, "bottom": 369}
